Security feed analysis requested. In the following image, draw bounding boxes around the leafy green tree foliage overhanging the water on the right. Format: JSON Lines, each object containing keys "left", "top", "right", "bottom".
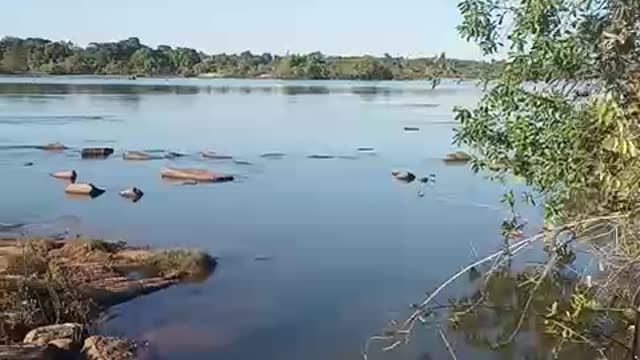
{"left": 455, "top": 0, "right": 640, "bottom": 219}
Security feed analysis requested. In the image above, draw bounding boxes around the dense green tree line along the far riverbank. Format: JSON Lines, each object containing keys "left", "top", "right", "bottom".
{"left": 0, "top": 37, "right": 502, "bottom": 80}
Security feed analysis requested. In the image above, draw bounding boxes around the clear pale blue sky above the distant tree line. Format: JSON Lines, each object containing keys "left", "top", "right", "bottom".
{"left": 0, "top": 0, "right": 480, "bottom": 58}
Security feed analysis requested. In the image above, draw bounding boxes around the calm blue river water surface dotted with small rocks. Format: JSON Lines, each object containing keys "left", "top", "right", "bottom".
{"left": 0, "top": 78, "right": 540, "bottom": 360}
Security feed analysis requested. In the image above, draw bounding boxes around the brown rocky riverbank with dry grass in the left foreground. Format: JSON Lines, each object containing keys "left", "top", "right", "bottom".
{"left": 0, "top": 238, "right": 216, "bottom": 359}
